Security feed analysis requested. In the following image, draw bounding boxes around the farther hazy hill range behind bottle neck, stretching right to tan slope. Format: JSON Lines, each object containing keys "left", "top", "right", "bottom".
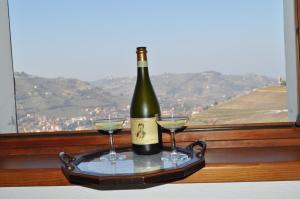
{"left": 91, "top": 71, "right": 277, "bottom": 111}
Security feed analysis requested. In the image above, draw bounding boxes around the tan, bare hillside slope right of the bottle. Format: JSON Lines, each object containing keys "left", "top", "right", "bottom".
{"left": 190, "top": 86, "right": 288, "bottom": 125}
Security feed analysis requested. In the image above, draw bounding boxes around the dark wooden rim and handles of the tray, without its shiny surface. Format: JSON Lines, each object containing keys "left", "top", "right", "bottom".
{"left": 61, "top": 141, "right": 206, "bottom": 189}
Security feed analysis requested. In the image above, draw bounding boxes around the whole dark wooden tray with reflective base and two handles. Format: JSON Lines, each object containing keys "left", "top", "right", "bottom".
{"left": 59, "top": 141, "right": 206, "bottom": 189}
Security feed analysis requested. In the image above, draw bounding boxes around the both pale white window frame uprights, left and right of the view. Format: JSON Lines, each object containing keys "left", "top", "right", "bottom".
{"left": 0, "top": 0, "right": 299, "bottom": 133}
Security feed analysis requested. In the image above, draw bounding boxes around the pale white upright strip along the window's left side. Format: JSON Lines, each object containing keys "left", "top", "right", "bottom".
{"left": 0, "top": 0, "right": 17, "bottom": 133}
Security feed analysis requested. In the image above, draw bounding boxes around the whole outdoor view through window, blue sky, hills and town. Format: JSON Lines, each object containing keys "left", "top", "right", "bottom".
{"left": 9, "top": 0, "right": 288, "bottom": 132}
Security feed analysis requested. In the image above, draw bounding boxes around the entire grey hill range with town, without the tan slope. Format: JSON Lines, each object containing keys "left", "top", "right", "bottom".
{"left": 15, "top": 71, "right": 277, "bottom": 132}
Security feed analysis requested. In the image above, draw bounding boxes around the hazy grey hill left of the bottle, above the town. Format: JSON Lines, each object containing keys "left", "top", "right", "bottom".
{"left": 15, "top": 73, "right": 127, "bottom": 117}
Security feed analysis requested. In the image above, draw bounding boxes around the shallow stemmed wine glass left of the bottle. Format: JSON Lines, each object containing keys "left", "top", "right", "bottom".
{"left": 95, "top": 117, "right": 126, "bottom": 162}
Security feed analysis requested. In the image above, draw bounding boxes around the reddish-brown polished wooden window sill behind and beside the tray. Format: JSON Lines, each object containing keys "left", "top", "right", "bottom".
{"left": 0, "top": 127, "right": 300, "bottom": 186}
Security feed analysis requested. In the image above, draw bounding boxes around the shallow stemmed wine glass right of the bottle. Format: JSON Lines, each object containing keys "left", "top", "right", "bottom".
{"left": 157, "top": 114, "right": 189, "bottom": 163}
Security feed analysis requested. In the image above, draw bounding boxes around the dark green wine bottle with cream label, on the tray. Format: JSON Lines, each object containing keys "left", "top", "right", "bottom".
{"left": 130, "top": 47, "right": 162, "bottom": 155}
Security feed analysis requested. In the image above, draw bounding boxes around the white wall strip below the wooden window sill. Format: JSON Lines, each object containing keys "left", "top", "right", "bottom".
{"left": 0, "top": 181, "right": 300, "bottom": 199}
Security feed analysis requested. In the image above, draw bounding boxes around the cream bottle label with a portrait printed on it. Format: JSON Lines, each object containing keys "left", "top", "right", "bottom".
{"left": 130, "top": 117, "right": 159, "bottom": 145}
